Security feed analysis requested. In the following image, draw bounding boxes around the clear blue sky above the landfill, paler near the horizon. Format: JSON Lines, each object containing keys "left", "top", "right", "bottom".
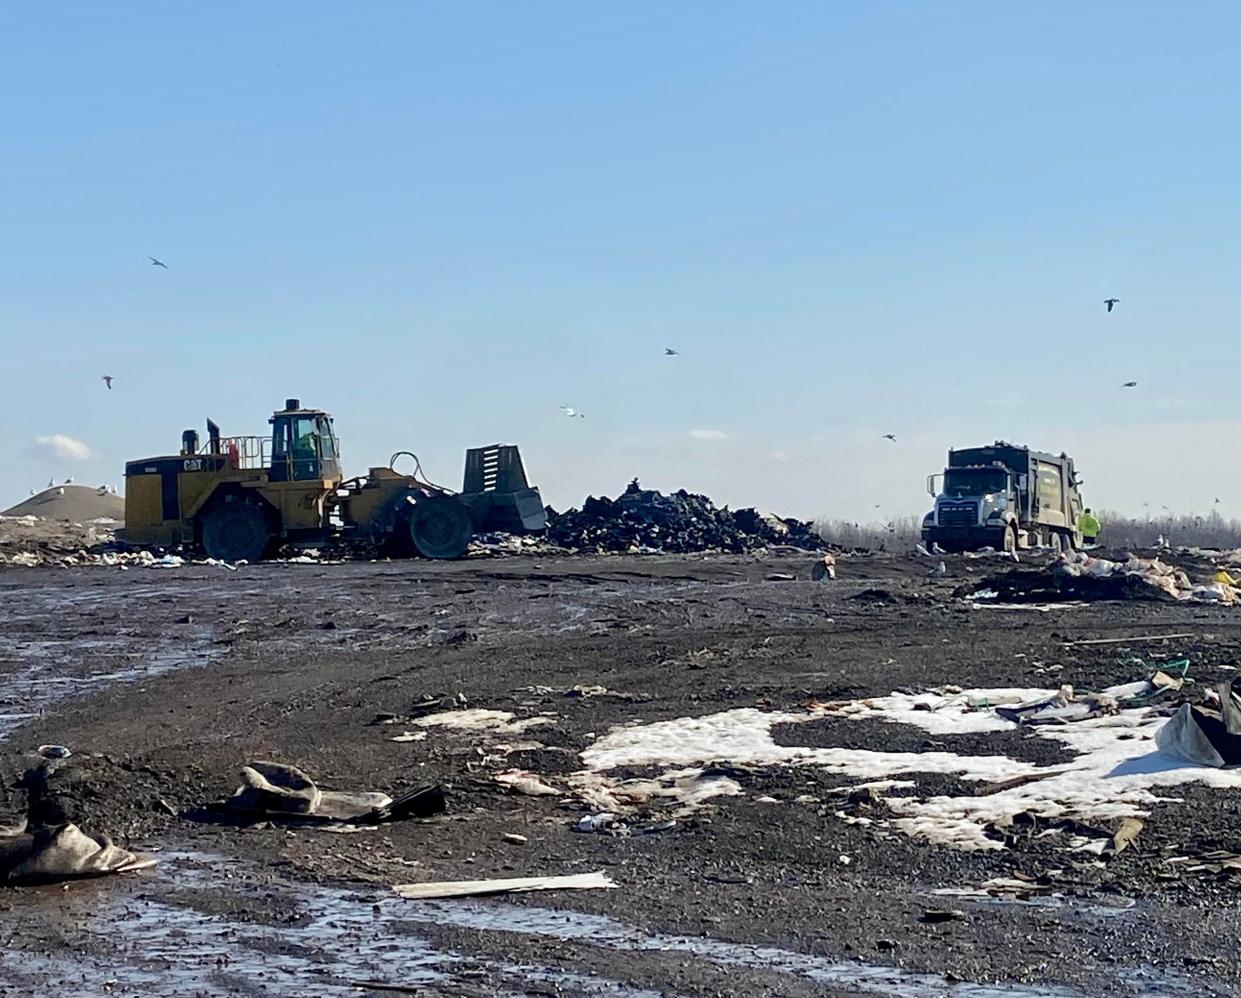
{"left": 0, "top": 2, "right": 1241, "bottom": 518}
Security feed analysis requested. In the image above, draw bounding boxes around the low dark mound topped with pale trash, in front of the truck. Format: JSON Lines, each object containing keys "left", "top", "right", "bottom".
{"left": 963, "top": 551, "right": 1241, "bottom": 606}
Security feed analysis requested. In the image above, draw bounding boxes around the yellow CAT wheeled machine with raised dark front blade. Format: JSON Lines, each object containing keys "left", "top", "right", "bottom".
{"left": 120, "top": 398, "right": 547, "bottom": 561}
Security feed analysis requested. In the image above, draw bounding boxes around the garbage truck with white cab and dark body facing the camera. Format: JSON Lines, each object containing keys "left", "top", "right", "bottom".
{"left": 922, "top": 441, "right": 1082, "bottom": 551}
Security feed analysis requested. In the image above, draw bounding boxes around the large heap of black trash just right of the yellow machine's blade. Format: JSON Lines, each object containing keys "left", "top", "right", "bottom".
{"left": 547, "top": 479, "right": 828, "bottom": 554}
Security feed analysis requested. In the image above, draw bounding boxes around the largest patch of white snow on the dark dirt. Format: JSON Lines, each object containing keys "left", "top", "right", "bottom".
{"left": 582, "top": 689, "right": 1241, "bottom": 849}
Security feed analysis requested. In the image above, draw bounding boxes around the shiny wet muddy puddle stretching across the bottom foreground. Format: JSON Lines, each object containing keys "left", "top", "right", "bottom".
{"left": 2, "top": 853, "right": 1201, "bottom": 998}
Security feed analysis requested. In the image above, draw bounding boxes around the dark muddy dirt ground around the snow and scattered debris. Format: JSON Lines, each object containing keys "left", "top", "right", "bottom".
{"left": 0, "top": 555, "right": 1241, "bottom": 998}
